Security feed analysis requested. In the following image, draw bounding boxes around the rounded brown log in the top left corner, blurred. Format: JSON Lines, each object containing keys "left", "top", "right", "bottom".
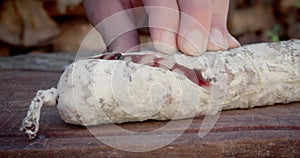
{"left": 0, "top": 0, "right": 59, "bottom": 47}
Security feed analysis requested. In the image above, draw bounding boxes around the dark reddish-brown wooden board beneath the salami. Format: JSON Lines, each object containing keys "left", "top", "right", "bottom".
{"left": 0, "top": 69, "right": 300, "bottom": 157}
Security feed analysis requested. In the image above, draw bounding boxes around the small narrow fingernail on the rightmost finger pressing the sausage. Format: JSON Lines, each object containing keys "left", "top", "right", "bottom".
{"left": 209, "top": 29, "right": 228, "bottom": 50}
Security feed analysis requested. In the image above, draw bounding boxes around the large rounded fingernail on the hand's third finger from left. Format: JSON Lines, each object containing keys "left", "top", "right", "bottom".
{"left": 182, "top": 30, "right": 207, "bottom": 56}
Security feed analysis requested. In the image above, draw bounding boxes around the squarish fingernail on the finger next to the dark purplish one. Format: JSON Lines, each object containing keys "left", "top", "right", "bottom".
{"left": 154, "top": 31, "right": 177, "bottom": 54}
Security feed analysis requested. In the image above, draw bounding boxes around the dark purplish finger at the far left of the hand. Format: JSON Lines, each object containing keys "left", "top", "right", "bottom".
{"left": 83, "top": 0, "right": 139, "bottom": 52}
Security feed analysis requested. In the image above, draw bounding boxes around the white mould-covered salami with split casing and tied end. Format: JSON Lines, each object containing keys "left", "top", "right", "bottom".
{"left": 21, "top": 40, "right": 300, "bottom": 138}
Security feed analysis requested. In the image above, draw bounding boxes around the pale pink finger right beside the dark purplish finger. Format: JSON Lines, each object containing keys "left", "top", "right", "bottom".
{"left": 143, "top": 0, "right": 179, "bottom": 54}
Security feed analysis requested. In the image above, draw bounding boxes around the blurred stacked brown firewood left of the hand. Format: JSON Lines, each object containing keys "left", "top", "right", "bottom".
{"left": 0, "top": 0, "right": 88, "bottom": 56}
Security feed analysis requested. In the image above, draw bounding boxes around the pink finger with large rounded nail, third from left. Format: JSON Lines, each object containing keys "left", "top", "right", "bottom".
{"left": 177, "top": 0, "right": 213, "bottom": 56}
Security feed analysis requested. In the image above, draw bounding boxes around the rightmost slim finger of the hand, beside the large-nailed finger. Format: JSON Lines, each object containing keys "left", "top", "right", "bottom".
{"left": 207, "top": 0, "right": 240, "bottom": 51}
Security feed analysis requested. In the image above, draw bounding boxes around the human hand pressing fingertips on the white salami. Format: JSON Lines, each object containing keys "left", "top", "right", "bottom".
{"left": 83, "top": 0, "right": 240, "bottom": 56}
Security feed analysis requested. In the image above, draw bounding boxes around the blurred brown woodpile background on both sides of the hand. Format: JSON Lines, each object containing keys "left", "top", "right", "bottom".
{"left": 0, "top": 0, "right": 300, "bottom": 57}
